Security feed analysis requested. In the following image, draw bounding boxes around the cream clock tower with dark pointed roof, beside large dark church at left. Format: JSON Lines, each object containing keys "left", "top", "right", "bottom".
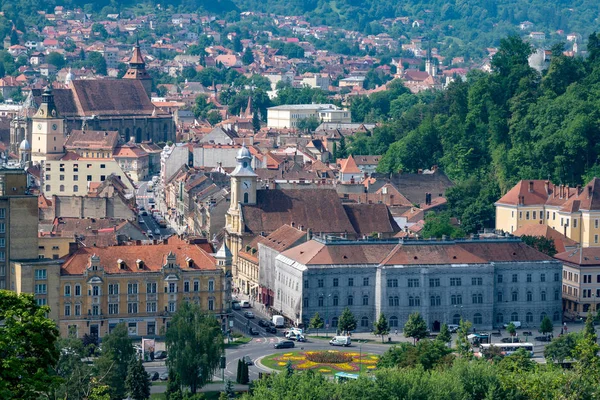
{"left": 31, "top": 87, "right": 65, "bottom": 163}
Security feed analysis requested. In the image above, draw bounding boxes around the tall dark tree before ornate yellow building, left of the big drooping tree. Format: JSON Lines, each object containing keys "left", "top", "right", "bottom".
{"left": 94, "top": 322, "right": 135, "bottom": 399}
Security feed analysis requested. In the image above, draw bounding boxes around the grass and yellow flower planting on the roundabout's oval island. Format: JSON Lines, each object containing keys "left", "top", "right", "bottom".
{"left": 260, "top": 349, "right": 379, "bottom": 375}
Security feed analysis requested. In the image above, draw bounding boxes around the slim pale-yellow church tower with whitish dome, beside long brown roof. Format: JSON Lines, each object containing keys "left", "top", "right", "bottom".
{"left": 225, "top": 145, "right": 258, "bottom": 268}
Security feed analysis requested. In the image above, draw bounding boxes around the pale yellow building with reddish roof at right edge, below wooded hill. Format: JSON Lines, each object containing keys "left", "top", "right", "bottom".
{"left": 494, "top": 178, "right": 600, "bottom": 247}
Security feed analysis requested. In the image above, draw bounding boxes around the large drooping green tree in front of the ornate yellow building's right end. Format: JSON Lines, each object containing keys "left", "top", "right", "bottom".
{"left": 165, "top": 302, "right": 224, "bottom": 394}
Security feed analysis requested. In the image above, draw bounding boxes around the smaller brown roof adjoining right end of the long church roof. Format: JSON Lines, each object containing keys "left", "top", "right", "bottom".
{"left": 344, "top": 204, "right": 400, "bottom": 235}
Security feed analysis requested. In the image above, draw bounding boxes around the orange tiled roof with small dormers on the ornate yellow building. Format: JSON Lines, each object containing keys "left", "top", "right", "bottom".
{"left": 61, "top": 240, "right": 217, "bottom": 275}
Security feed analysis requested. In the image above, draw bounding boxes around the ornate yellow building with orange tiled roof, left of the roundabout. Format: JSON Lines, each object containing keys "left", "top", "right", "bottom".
{"left": 13, "top": 238, "right": 231, "bottom": 337}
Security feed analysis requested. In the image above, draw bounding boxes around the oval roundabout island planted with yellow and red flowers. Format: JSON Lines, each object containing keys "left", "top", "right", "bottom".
{"left": 260, "top": 350, "right": 379, "bottom": 375}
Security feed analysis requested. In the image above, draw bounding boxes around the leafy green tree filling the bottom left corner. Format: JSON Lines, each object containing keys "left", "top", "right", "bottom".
{"left": 0, "top": 290, "right": 59, "bottom": 399}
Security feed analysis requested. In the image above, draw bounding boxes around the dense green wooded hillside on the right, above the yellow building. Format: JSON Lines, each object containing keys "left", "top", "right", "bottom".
{"left": 349, "top": 35, "right": 600, "bottom": 231}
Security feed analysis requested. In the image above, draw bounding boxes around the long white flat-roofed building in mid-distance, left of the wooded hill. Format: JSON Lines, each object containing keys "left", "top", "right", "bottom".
{"left": 267, "top": 104, "right": 352, "bottom": 129}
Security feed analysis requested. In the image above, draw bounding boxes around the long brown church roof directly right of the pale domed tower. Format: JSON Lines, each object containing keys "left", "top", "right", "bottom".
{"left": 242, "top": 189, "right": 354, "bottom": 234}
